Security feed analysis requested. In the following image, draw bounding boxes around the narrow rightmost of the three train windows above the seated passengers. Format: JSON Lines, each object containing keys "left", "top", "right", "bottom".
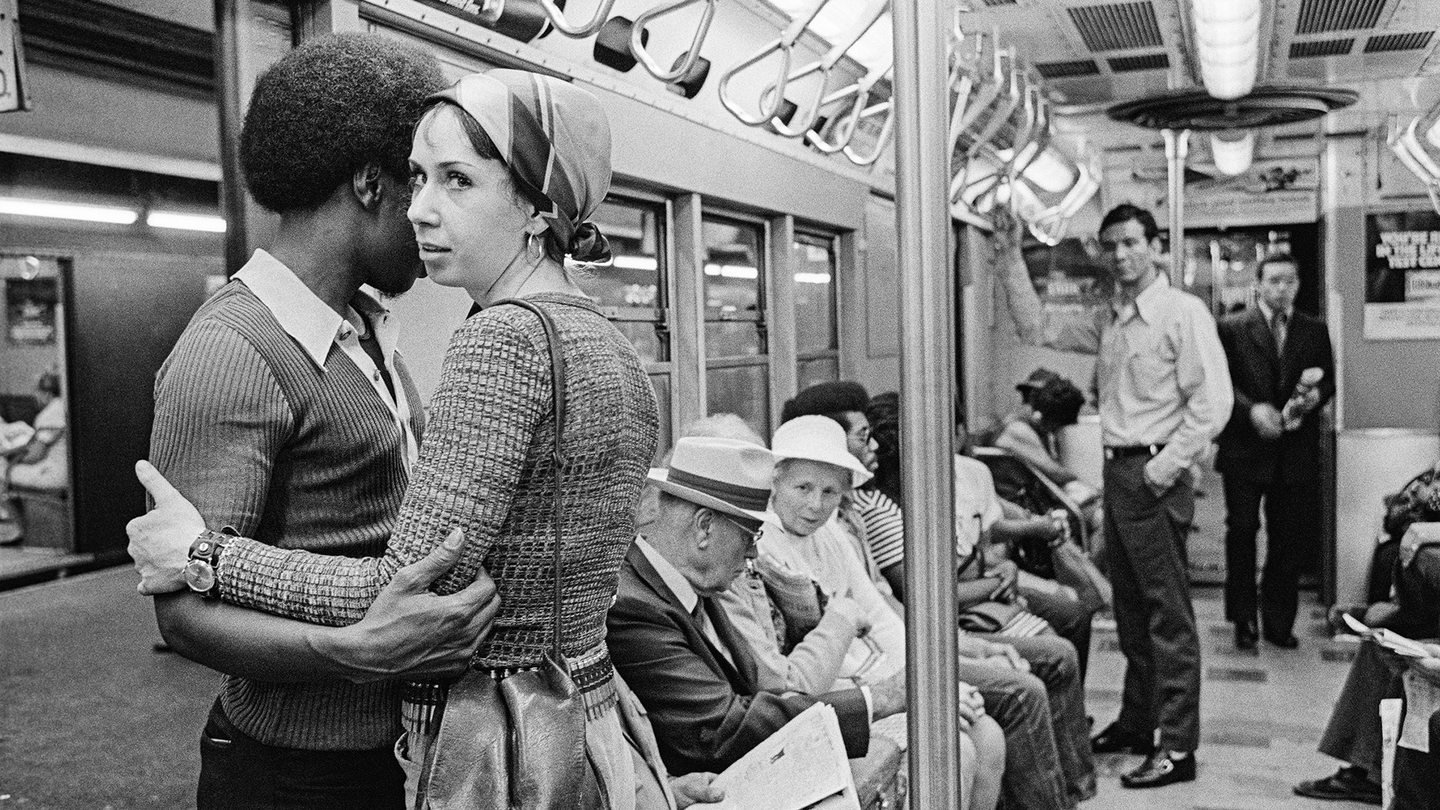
{"left": 793, "top": 232, "right": 840, "bottom": 391}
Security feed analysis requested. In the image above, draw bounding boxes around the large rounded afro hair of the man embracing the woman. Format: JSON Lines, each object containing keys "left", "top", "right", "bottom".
{"left": 240, "top": 33, "right": 448, "bottom": 212}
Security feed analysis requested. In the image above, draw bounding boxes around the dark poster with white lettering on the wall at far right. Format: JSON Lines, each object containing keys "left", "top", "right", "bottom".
{"left": 1365, "top": 210, "right": 1440, "bottom": 340}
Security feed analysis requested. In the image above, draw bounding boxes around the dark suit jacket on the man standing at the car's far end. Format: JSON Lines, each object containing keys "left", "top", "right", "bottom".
{"left": 1215, "top": 301, "right": 1335, "bottom": 483}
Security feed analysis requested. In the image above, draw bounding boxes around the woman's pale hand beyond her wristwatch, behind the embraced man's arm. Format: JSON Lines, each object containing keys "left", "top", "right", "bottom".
{"left": 125, "top": 461, "right": 204, "bottom": 597}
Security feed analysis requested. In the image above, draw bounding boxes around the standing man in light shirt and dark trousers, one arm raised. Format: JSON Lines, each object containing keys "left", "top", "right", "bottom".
{"left": 995, "top": 205, "right": 1234, "bottom": 788}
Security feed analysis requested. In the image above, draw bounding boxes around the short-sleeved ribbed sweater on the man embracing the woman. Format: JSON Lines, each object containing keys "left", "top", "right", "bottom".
{"left": 150, "top": 281, "right": 419, "bottom": 749}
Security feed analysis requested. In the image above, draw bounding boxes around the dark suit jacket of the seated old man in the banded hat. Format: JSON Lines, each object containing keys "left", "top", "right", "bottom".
{"left": 606, "top": 546, "right": 870, "bottom": 775}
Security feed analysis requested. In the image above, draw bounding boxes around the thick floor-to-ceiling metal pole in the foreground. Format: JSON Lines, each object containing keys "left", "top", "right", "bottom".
{"left": 891, "top": 0, "right": 960, "bottom": 809}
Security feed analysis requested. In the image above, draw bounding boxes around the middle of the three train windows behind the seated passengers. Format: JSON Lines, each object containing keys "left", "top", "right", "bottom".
{"left": 700, "top": 213, "right": 770, "bottom": 435}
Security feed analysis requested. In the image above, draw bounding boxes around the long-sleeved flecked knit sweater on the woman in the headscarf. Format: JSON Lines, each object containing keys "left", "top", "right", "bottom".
{"left": 217, "top": 294, "right": 658, "bottom": 667}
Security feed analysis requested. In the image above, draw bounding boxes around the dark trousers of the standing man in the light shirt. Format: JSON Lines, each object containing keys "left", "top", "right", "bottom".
{"left": 1104, "top": 454, "right": 1200, "bottom": 751}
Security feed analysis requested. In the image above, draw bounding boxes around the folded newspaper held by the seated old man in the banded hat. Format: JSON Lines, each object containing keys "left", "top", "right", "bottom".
{"left": 713, "top": 703, "right": 860, "bottom": 810}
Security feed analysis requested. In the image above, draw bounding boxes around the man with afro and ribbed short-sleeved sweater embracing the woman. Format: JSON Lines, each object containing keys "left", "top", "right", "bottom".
{"left": 131, "top": 35, "right": 495, "bottom": 810}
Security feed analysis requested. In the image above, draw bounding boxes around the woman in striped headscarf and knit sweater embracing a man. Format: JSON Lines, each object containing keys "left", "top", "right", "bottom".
{"left": 132, "top": 71, "right": 694, "bottom": 810}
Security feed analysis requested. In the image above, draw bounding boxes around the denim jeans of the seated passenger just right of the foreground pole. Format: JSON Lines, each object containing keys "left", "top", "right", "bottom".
{"left": 958, "top": 636, "right": 1094, "bottom": 810}
